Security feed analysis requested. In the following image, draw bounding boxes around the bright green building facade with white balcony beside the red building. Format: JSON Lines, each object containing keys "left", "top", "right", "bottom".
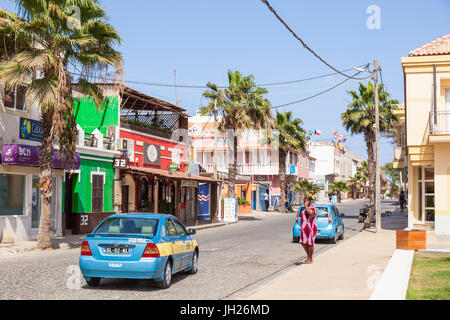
{"left": 62, "top": 86, "right": 121, "bottom": 234}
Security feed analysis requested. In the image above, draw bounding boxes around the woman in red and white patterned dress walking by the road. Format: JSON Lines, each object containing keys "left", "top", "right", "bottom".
{"left": 300, "top": 197, "right": 317, "bottom": 263}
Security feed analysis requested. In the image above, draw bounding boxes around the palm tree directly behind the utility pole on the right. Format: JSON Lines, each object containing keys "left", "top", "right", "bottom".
{"left": 341, "top": 82, "right": 398, "bottom": 229}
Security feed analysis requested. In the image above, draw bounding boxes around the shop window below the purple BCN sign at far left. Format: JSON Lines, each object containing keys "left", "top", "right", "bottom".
{"left": 0, "top": 174, "right": 25, "bottom": 216}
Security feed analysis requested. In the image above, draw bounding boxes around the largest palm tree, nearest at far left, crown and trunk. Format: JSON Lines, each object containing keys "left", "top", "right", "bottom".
{"left": 0, "top": 0, "right": 122, "bottom": 249}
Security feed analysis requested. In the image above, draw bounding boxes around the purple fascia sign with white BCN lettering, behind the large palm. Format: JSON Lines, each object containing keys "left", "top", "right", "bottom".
{"left": 2, "top": 144, "right": 80, "bottom": 169}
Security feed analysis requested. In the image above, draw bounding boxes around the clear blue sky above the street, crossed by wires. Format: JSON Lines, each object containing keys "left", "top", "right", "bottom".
{"left": 2, "top": 0, "right": 450, "bottom": 164}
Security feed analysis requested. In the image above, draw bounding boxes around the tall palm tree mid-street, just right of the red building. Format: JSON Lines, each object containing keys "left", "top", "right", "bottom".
{"left": 200, "top": 70, "right": 273, "bottom": 198}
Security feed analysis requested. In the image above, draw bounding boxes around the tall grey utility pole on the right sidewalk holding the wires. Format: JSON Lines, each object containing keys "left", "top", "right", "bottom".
{"left": 373, "top": 59, "right": 381, "bottom": 232}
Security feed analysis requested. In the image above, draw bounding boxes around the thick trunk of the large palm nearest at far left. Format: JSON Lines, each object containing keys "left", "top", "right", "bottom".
{"left": 36, "top": 112, "right": 53, "bottom": 249}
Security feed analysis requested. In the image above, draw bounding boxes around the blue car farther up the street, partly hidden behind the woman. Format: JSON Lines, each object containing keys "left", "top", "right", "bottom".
{"left": 292, "top": 204, "right": 344, "bottom": 243}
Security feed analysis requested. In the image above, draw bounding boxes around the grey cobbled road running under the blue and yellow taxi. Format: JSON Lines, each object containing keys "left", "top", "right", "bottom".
{"left": 0, "top": 200, "right": 398, "bottom": 299}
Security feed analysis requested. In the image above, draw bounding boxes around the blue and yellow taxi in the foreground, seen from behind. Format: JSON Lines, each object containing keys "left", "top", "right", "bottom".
{"left": 79, "top": 213, "right": 199, "bottom": 289}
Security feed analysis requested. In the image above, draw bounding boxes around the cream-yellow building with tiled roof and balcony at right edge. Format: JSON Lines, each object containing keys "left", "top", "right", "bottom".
{"left": 400, "top": 35, "right": 450, "bottom": 234}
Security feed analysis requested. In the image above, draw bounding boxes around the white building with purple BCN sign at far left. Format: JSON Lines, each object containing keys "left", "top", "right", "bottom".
{"left": 0, "top": 84, "right": 64, "bottom": 240}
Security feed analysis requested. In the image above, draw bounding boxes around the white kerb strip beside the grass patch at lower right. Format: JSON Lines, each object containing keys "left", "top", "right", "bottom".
{"left": 369, "top": 249, "right": 414, "bottom": 300}
